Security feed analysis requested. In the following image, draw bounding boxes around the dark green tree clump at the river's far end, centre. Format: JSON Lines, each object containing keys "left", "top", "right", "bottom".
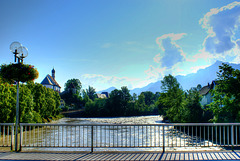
{"left": 85, "top": 86, "right": 158, "bottom": 117}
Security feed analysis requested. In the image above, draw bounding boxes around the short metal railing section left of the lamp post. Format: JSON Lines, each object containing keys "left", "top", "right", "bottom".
{"left": 0, "top": 123, "right": 15, "bottom": 150}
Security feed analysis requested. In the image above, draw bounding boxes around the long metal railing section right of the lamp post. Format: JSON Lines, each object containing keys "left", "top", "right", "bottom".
{"left": 20, "top": 123, "right": 240, "bottom": 151}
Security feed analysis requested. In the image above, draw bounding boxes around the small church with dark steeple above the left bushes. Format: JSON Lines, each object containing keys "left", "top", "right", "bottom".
{"left": 41, "top": 68, "right": 61, "bottom": 93}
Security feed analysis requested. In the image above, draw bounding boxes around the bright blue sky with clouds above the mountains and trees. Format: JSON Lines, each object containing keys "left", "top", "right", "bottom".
{"left": 0, "top": 0, "right": 240, "bottom": 91}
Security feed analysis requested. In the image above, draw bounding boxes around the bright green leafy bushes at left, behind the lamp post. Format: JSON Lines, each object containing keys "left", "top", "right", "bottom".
{"left": 0, "top": 82, "right": 60, "bottom": 123}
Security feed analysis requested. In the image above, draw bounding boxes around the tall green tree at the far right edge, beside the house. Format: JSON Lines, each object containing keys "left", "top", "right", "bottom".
{"left": 208, "top": 63, "right": 240, "bottom": 122}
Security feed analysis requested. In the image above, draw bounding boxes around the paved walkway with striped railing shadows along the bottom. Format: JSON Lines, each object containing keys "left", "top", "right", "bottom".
{"left": 0, "top": 151, "right": 240, "bottom": 161}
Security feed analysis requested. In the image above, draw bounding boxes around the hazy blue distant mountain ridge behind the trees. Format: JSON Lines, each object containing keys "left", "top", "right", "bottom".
{"left": 130, "top": 61, "right": 240, "bottom": 95}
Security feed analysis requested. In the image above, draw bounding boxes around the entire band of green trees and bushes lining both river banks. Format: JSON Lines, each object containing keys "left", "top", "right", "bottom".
{"left": 0, "top": 64, "right": 240, "bottom": 123}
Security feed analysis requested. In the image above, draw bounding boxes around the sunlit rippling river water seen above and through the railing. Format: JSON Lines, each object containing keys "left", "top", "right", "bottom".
{"left": 23, "top": 115, "right": 220, "bottom": 151}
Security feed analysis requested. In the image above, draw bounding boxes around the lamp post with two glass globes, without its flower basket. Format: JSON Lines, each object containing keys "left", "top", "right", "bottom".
{"left": 10, "top": 41, "right": 28, "bottom": 151}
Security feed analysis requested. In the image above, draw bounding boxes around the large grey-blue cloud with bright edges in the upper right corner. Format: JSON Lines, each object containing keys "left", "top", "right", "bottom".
{"left": 199, "top": 2, "right": 240, "bottom": 54}
